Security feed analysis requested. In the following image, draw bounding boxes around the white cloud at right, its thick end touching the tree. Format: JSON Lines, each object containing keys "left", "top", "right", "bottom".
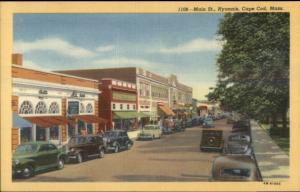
{"left": 153, "top": 38, "right": 222, "bottom": 54}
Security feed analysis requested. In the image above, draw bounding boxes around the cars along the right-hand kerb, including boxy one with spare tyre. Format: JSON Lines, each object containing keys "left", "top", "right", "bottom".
{"left": 200, "top": 115, "right": 261, "bottom": 181}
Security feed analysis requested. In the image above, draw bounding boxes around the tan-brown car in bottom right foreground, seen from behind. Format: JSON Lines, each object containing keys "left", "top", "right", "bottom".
{"left": 210, "top": 155, "right": 261, "bottom": 181}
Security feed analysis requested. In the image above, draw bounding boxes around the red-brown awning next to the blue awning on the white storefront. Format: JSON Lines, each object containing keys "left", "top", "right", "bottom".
{"left": 24, "top": 116, "right": 69, "bottom": 128}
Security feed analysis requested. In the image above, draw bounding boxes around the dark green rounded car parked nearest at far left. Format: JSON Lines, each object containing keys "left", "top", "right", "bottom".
{"left": 12, "top": 141, "right": 67, "bottom": 178}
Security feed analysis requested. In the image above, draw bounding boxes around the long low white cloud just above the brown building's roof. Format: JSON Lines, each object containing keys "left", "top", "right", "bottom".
{"left": 93, "top": 57, "right": 170, "bottom": 69}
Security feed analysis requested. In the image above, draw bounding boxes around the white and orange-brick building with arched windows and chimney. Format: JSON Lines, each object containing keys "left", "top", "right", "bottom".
{"left": 12, "top": 54, "right": 103, "bottom": 150}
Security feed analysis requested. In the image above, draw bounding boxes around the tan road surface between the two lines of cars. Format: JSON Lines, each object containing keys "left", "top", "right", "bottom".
{"left": 15, "top": 120, "right": 230, "bottom": 182}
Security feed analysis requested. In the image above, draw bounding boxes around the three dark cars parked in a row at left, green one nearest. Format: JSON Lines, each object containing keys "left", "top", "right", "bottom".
{"left": 12, "top": 130, "right": 133, "bottom": 178}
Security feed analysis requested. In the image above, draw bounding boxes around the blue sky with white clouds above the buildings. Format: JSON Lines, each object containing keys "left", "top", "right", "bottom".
{"left": 14, "top": 14, "right": 223, "bottom": 99}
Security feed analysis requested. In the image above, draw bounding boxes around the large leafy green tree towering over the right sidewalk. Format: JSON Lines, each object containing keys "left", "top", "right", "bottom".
{"left": 207, "top": 13, "right": 290, "bottom": 135}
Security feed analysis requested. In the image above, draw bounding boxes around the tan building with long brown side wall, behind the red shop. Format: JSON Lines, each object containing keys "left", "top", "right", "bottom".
{"left": 58, "top": 67, "right": 193, "bottom": 120}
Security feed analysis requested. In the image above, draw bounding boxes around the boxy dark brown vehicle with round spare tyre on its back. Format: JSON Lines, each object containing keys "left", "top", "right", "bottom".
{"left": 200, "top": 129, "right": 224, "bottom": 152}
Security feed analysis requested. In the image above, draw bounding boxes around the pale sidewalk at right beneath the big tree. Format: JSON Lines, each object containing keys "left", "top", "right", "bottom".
{"left": 251, "top": 121, "right": 289, "bottom": 181}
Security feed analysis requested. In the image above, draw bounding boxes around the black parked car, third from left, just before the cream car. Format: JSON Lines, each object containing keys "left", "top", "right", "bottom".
{"left": 103, "top": 130, "right": 133, "bottom": 153}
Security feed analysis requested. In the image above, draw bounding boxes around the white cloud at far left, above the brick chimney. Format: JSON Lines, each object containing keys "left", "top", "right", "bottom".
{"left": 14, "top": 37, "right": 95, "bottom": 58}
